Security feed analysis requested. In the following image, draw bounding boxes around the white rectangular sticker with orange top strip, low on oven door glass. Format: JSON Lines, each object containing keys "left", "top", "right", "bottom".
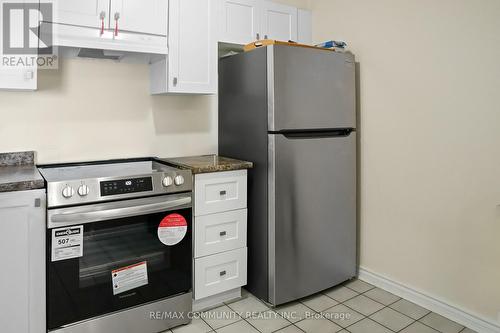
{"left": 111, "top": 261, "right": 148, "bottom": 295}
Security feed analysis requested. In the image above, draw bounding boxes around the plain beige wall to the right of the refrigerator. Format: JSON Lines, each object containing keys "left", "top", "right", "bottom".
{"left": 310, "top": 0, "right": 500, "bottom": 322}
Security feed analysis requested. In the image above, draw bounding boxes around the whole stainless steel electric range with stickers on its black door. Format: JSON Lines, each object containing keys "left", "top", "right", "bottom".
{"left": 39, "top": 159, "right": 192, "bottom": 333}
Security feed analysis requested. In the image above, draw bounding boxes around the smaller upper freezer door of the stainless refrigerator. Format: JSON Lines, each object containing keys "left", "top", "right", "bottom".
{"left": 268, "top": 45, "right": 356, "bottom": 131}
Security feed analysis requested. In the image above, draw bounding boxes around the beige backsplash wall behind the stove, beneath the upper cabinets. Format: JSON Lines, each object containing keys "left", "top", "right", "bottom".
{"left": 0, "top": 59, "right": 217, "bottom": 163}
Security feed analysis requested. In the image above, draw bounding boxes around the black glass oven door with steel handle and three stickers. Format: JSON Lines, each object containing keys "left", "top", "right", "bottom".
{"left": 47, "top": 193, "right": 192, "bottom": 330}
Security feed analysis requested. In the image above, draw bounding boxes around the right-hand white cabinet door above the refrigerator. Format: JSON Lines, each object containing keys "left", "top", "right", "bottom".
{"left": 262, "top": 1, "right": 297, "bottom": 41}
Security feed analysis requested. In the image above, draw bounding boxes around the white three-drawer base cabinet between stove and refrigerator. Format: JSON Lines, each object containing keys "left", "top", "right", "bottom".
{"left": 193, "top": 170, "right": 247, "bottom": 310}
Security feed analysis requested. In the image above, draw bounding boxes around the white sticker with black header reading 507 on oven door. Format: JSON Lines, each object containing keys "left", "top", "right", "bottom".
{"left": 52, "top": 225, "right": 83, "bottom": 261}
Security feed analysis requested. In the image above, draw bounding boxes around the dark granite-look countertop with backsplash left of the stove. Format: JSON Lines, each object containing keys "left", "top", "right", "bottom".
{"left": 0, "top": 151, "right": 45, "bottom": 192}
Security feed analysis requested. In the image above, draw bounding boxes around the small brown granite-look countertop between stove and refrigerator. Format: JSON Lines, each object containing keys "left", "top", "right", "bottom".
{"left": 160, "top": 155, "right": 253, "bottom": 174}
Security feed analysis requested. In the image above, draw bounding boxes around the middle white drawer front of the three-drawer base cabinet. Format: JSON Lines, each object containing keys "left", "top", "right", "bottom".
{"left": 194, "top": 209, "right": 247, "bottom": 258}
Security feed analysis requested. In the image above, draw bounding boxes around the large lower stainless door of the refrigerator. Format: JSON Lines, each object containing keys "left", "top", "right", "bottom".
{"left": 268, "top": 132, "right": 356, "bottom": 305}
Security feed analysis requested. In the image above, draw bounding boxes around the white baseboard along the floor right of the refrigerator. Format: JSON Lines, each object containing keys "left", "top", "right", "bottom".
{"left": 359, "top": 267, "right": 500, "bottom": 333}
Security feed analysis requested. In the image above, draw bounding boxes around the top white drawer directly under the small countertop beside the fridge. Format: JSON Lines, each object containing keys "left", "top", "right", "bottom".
{"left": 194, "top": 170, "right": 247, "bottom": 216}
